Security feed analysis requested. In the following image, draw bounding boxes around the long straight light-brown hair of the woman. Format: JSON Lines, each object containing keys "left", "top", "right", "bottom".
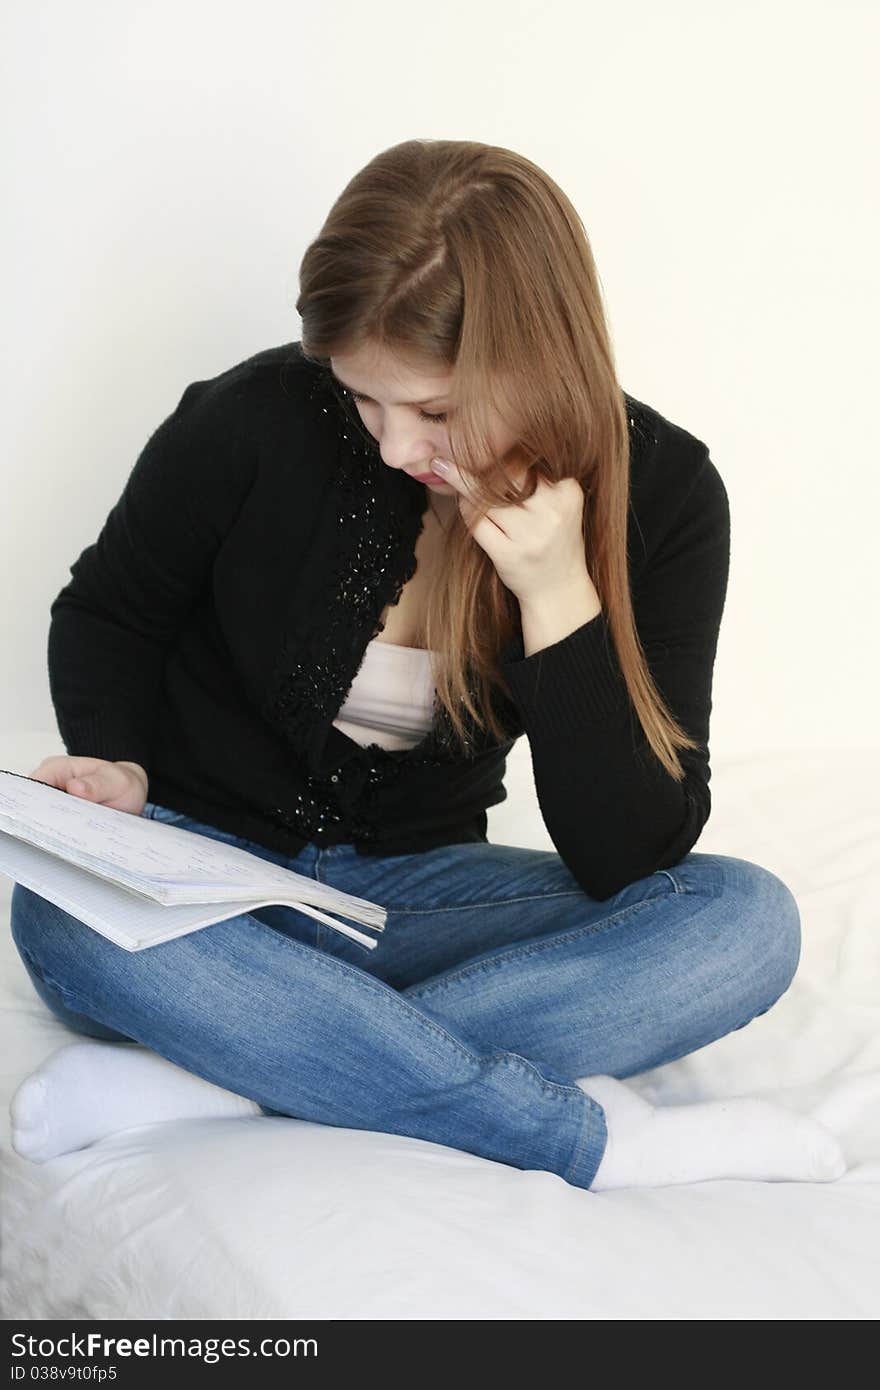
{"left": 296, "top": 140, "right": 699, "bottom": 781}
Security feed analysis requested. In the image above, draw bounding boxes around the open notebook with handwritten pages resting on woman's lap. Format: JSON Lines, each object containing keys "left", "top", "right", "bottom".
{"left": 0, "top": 770, "right": 388, "bottom": 951}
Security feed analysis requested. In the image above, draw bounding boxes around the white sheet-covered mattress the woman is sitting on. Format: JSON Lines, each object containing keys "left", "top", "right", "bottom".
{"left": 0, "top": 735, "right": 880, "bottom": 1321}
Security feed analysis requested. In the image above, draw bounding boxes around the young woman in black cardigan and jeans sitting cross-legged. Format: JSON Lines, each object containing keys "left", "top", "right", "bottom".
{"left": 13, "top": 140, "right": 845, "bottom": 1190}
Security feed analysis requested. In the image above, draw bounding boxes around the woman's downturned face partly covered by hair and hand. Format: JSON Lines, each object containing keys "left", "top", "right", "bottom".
{"left": 329, "top": 346, "right": 516, "bottom": 500}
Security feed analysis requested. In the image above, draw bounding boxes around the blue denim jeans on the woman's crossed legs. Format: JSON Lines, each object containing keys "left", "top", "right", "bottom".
{"left": 11, "top": 802, "right": 801, "bottom": 1188}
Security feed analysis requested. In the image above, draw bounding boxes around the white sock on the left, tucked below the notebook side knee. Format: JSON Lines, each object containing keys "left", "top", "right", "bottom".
{"left": 10, "top": 1040, "right": 263, "bottom": 1163}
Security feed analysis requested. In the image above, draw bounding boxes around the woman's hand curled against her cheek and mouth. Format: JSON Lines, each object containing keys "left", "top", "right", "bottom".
{"left": 432, "top": 459, "right": 592, "bottom": 605}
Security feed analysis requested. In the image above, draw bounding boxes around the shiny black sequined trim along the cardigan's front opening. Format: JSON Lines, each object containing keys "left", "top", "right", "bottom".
{"left": 254, "top": 349, "right": 653, "bottom": 844}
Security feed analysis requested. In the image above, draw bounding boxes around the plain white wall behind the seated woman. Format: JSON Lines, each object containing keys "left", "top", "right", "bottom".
{"left": 0, "top": 0, "right": 880, "bottom": 771}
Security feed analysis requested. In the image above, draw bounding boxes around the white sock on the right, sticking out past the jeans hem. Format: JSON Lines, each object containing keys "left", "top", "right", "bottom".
{"left": 577, "top": 1076, "right": 847, "bottom": 1191}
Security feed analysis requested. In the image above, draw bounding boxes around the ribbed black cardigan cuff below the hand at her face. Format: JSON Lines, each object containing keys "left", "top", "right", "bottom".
{"left": 500, "top": 612, "right": 630, "bottom": 738}
